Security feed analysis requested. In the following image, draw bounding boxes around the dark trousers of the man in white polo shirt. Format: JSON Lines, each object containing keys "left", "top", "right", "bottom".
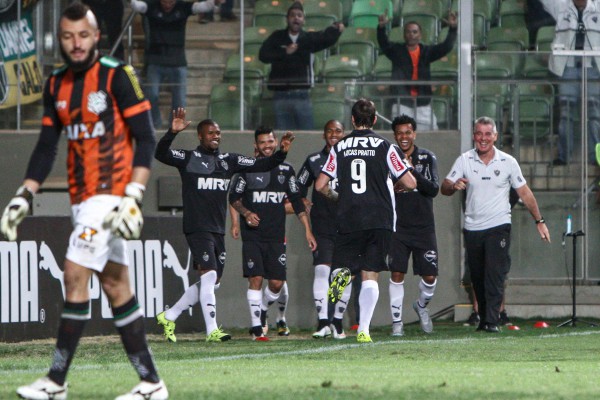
{"left": 463, "top": 224, "right": 511, "bottom": 325}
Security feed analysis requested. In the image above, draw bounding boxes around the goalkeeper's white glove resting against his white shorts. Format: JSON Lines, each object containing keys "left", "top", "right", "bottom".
{"left": 104, "top": 182, "right": 146, "bottom": 240}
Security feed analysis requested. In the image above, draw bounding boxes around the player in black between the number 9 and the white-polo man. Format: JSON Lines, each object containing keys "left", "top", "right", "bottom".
{"left": 389, "top": 115, "right": 440, "bottom": 336}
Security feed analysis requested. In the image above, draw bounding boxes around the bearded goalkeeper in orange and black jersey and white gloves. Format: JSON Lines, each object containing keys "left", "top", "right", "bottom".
{"left": 0, "top": 2, "right": 168, "bottom": 400}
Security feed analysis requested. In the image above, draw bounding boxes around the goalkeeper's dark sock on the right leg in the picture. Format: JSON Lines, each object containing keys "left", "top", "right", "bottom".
{"left": 113, "top": 296, "right": 160, "bottom": 383}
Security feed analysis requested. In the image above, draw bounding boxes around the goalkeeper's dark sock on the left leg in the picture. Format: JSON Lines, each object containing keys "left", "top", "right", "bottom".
{"left": 48, "top": 301, "right": 91, "bottom": 386}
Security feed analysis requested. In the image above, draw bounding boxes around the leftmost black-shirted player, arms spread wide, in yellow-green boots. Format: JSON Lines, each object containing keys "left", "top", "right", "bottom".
{"left": 154, "top": 108, "right": 294, "bottom": 342}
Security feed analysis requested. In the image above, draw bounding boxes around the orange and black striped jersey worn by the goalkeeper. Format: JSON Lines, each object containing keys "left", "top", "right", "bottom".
{"left": 42, "top": 57, "right": 150, "bottom": 204}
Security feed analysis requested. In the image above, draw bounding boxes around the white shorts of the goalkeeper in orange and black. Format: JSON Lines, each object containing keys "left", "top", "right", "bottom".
{"left": 66, "top": 195, "right": 129, "bottom": 272}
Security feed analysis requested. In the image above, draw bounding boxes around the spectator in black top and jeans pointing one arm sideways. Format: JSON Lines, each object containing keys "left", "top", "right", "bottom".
{"left": 258, "top": 1, "right": 344, "bottom": 130}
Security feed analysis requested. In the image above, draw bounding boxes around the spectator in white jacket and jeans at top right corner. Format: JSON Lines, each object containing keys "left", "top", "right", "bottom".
{"left": 540, "top": 0, "right": 600, "bottom": 165}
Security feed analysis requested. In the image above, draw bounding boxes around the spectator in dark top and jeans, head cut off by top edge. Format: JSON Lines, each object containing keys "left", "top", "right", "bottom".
{"left": 131, "top": 0, "right": 220, "bottom": 129}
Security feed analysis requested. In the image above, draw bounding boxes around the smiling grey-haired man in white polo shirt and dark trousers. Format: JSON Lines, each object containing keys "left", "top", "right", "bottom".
{"left": 441, "top": 117, "right": 550, "bottom": 333}
